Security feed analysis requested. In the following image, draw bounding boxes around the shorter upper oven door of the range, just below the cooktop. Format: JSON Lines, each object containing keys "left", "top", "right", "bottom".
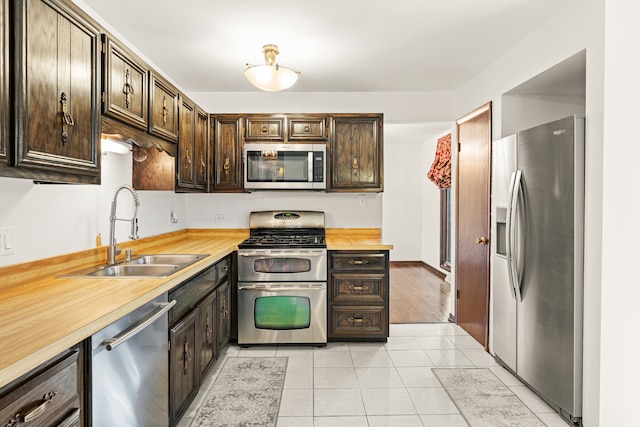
{"left": 238, "top": 249, "right": 327, "bottom": 282}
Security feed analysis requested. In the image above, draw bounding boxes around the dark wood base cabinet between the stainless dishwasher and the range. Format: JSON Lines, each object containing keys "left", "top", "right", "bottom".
{"left": 169, "top": 256, "right": 231, "bottom": 426}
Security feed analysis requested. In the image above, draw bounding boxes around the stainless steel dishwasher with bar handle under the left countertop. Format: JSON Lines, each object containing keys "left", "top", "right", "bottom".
{"left": 91, "top": 293, "right": 175, "bottom": 427}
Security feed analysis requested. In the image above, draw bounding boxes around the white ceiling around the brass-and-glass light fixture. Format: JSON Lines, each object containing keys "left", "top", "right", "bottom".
{"left": 78, "top": 0, "right": 570, "bottom": 92}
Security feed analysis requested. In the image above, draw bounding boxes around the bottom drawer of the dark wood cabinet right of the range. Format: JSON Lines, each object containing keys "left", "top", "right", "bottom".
{"left": 329, "top": 305, "right": 388, "bottom": 339}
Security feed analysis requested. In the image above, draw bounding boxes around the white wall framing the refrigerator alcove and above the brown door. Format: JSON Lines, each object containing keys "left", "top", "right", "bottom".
{"left": 457, "top": 0, "right": 604, "bottom": 427}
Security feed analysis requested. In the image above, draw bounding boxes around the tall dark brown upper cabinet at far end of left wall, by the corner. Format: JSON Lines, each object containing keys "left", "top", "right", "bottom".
{"left": 176, "top": 96, "right": 209, "bottom": 191}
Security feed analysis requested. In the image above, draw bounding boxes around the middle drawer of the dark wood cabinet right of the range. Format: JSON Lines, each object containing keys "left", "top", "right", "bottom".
{"left": 331, "top": 273, "right": 386, "bottom": 305}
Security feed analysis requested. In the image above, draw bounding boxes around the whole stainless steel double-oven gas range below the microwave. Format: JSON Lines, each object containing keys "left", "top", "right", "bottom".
{"left": 238, "top": 211, "right": 327, "bottom": 345}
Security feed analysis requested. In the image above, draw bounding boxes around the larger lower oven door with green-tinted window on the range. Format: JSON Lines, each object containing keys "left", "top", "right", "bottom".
{"left": 238, "top": 282, "right": 327, "bottom": 345}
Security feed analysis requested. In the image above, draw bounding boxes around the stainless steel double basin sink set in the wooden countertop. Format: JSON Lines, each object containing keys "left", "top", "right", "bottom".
{"left": 60, "top": 254, "right": 209, "bottom": 278}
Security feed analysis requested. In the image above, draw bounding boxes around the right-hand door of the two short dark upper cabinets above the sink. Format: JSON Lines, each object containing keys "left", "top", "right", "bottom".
{"left": 149, "top": 71, "right": 180, "bottom": 143}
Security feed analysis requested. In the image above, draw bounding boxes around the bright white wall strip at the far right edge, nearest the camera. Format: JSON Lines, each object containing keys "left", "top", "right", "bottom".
{"left": 593, "top": 0, "right": 640, "bottom": 426}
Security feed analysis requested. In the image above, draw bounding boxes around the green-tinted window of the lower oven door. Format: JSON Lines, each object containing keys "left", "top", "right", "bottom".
{"left": 254, "top": 296, "right": 311, "bottom": 330}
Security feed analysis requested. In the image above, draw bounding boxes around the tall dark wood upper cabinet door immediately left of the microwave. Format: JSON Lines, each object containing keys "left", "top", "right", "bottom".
{"left": 211, "top": 115, "right": 244, "bottom": 193}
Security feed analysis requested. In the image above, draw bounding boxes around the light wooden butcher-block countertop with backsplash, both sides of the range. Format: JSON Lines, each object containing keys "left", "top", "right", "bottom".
{"left": 0, "top": 229, "right": 393, "bottom": 387}
